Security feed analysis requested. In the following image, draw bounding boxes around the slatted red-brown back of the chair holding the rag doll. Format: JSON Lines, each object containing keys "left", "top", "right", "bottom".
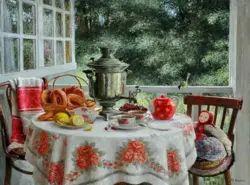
{"left": 184, "top": 95, "right": 243, "bottom": 146}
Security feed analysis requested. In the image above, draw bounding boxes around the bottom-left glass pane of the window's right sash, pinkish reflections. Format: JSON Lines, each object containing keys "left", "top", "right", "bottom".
{"left": 44, "top": 40, "right": 54, "bottom": 66}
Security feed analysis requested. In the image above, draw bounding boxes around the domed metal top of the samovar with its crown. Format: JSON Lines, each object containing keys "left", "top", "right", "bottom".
{"left": 87, "top": 47, "right": 129, "bottom": 73}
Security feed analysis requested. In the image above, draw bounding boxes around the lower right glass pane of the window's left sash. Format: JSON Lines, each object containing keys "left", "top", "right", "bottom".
{"left": 23, "top": 39, "right": 36, "bottom": 70}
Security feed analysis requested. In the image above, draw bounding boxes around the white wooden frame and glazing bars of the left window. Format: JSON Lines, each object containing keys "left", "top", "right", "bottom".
{"left": 0, "top": 0, "right": 77, "bottom": 82}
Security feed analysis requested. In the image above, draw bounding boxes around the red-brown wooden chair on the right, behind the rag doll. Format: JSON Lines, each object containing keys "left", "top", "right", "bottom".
{"left": 184, "top": 95, "right": 243, "bottom": 185}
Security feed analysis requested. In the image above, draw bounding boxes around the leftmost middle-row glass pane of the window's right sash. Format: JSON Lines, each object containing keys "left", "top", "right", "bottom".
{"left": 43, "top": 9, "right": 54, "bottom": 37}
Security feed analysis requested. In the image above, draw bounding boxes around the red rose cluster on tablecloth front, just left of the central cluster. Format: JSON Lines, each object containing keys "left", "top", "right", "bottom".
{"left": 73, "top": 142, "right": 105, "bottom": 172}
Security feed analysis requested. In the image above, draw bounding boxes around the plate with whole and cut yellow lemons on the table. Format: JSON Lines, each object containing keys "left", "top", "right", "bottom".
{"left": 53, "top": 112, "right": 92, "bottom": 131}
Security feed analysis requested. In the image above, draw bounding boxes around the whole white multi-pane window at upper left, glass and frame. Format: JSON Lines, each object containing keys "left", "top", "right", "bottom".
{"left": 0, "top": 0, "right": 76, "bottom": 81}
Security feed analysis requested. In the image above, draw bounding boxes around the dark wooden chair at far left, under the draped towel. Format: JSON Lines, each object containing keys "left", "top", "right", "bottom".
{"left": 0, "top": 78, "right": 47, "bottom": 185}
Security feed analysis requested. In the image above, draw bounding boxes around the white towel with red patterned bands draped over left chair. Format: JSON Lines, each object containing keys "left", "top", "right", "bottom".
{"left": 8, "top": 77, "right": 44, "bottom": 151}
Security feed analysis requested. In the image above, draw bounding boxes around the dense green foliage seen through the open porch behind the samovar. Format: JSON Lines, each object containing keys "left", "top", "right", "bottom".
{"left": 76, "top": 0, "right": 229, "bottom": 86}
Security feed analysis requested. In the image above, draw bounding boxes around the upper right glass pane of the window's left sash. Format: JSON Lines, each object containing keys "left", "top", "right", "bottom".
{"left": 23, "top": 3, "right": 36, "bottom": 35}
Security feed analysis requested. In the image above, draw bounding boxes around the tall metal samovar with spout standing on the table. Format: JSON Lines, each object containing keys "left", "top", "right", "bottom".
{"left": 83, "top": 47, "right": 136, "bottom": 120}
